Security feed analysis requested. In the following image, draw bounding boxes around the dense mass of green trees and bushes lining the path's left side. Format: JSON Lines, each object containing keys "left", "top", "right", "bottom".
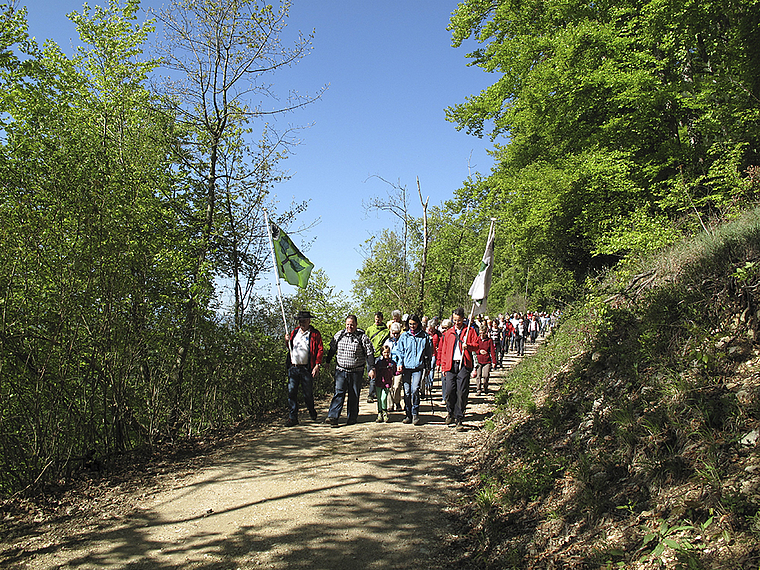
{"left": 0, "top": 0, "right": 318, "bottom": 495}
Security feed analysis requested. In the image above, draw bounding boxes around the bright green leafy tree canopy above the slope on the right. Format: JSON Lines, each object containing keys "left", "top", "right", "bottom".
{"left": 447, "top": 0, "right": 760, "bottom": 296}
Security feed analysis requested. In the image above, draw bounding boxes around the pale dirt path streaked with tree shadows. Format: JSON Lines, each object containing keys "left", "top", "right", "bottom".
{"left": 0, "top": 340, "right": 534, "bottom": 570}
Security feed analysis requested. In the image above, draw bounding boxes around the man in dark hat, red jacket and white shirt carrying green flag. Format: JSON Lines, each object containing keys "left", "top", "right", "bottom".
{"left": 285, "top": 311, "right": 324, "bottom": 427}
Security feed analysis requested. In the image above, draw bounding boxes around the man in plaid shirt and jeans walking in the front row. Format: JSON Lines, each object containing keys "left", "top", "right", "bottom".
{"left": 325, "top": 315, "right": 375, "bottom": 426}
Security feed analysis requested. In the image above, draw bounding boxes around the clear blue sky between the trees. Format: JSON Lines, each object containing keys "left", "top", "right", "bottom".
{"left": 22, "top": 0, "right": 496, "bottom": 302}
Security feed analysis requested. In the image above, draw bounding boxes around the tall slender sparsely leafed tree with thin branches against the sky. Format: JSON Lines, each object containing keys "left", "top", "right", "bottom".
{"left": 156, "top": 0, "right": 322, "bottom": 422}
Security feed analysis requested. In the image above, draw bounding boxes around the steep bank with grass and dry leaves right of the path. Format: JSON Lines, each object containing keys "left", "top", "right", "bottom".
{"left": 452, "top": 212, "right": 760, "bottom": 569}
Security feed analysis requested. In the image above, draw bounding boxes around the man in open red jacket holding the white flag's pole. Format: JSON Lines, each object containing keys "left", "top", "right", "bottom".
{"left": 440, "top": 307, "right": 478, "bottom": 431}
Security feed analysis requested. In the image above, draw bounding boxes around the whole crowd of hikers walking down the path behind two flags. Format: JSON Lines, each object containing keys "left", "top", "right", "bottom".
{"left": 285, "top": 307, "right": 559, "bottom": 431}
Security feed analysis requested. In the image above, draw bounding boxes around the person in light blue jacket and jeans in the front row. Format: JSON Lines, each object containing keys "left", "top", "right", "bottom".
{"left": 391, "top": 315, "right": 433, "bottom": 425}
